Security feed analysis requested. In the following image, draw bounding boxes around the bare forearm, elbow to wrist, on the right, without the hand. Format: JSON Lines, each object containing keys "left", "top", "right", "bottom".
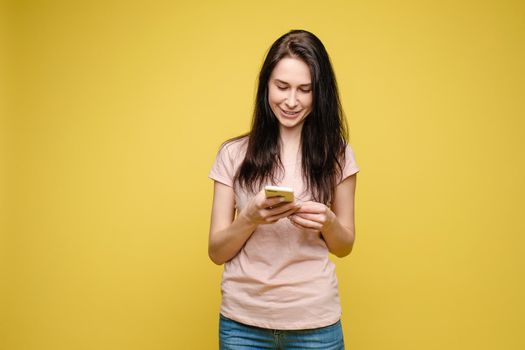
{"left": 321, "top": 210, "right": 355, "bottom": 258}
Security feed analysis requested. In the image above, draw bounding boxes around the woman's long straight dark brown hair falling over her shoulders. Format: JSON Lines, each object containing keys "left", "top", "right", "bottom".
{"left": 227, "top": 30, "right": 348, "bottom": 204}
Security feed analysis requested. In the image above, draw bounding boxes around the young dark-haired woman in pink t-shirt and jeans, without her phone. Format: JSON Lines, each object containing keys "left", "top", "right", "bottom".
{"left": 209, "top": 30, "right": 359, "bottom": 349}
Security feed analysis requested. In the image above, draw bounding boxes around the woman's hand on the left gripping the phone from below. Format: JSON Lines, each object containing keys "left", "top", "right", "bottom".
{"left": 240, "top": 190, "right": 301, "bottom": 225}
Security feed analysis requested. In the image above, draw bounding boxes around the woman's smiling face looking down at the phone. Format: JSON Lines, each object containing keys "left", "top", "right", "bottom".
{"left": 268, "top": 57, "right": 313, "bottom": 130}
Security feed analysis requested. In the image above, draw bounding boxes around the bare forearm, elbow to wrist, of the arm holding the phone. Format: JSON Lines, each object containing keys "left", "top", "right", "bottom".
{"left": 208, "top": 213, "right": 257, "bottom": 265}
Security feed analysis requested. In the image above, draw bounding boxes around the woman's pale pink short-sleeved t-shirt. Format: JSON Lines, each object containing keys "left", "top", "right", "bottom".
{"left": 209, "top": 138, "right": 359, "bottom": 330}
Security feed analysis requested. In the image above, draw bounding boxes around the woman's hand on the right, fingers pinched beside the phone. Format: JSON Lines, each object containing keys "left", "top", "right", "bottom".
{"left": 288, "top": 201, "right": 335, "bottom": 232}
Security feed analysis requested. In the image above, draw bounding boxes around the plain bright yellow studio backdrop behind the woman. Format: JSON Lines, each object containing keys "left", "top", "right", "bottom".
{"left": 0, "top": 0, "right": 525, "bottom": 350}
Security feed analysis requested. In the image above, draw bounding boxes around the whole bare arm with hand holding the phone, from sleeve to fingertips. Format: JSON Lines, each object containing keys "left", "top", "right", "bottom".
{"left": 208, "top": 181, "right": 298, "bottom": 265}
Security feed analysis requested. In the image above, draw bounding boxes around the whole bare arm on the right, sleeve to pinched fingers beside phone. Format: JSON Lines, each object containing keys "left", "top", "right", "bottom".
{"left": 290, "top": 174, "right": 356, "bottom": 258}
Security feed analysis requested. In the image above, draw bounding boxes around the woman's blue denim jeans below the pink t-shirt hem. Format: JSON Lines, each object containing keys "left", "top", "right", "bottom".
{"left": 219, "top": 315, "right": 345, "bottom": 350}
